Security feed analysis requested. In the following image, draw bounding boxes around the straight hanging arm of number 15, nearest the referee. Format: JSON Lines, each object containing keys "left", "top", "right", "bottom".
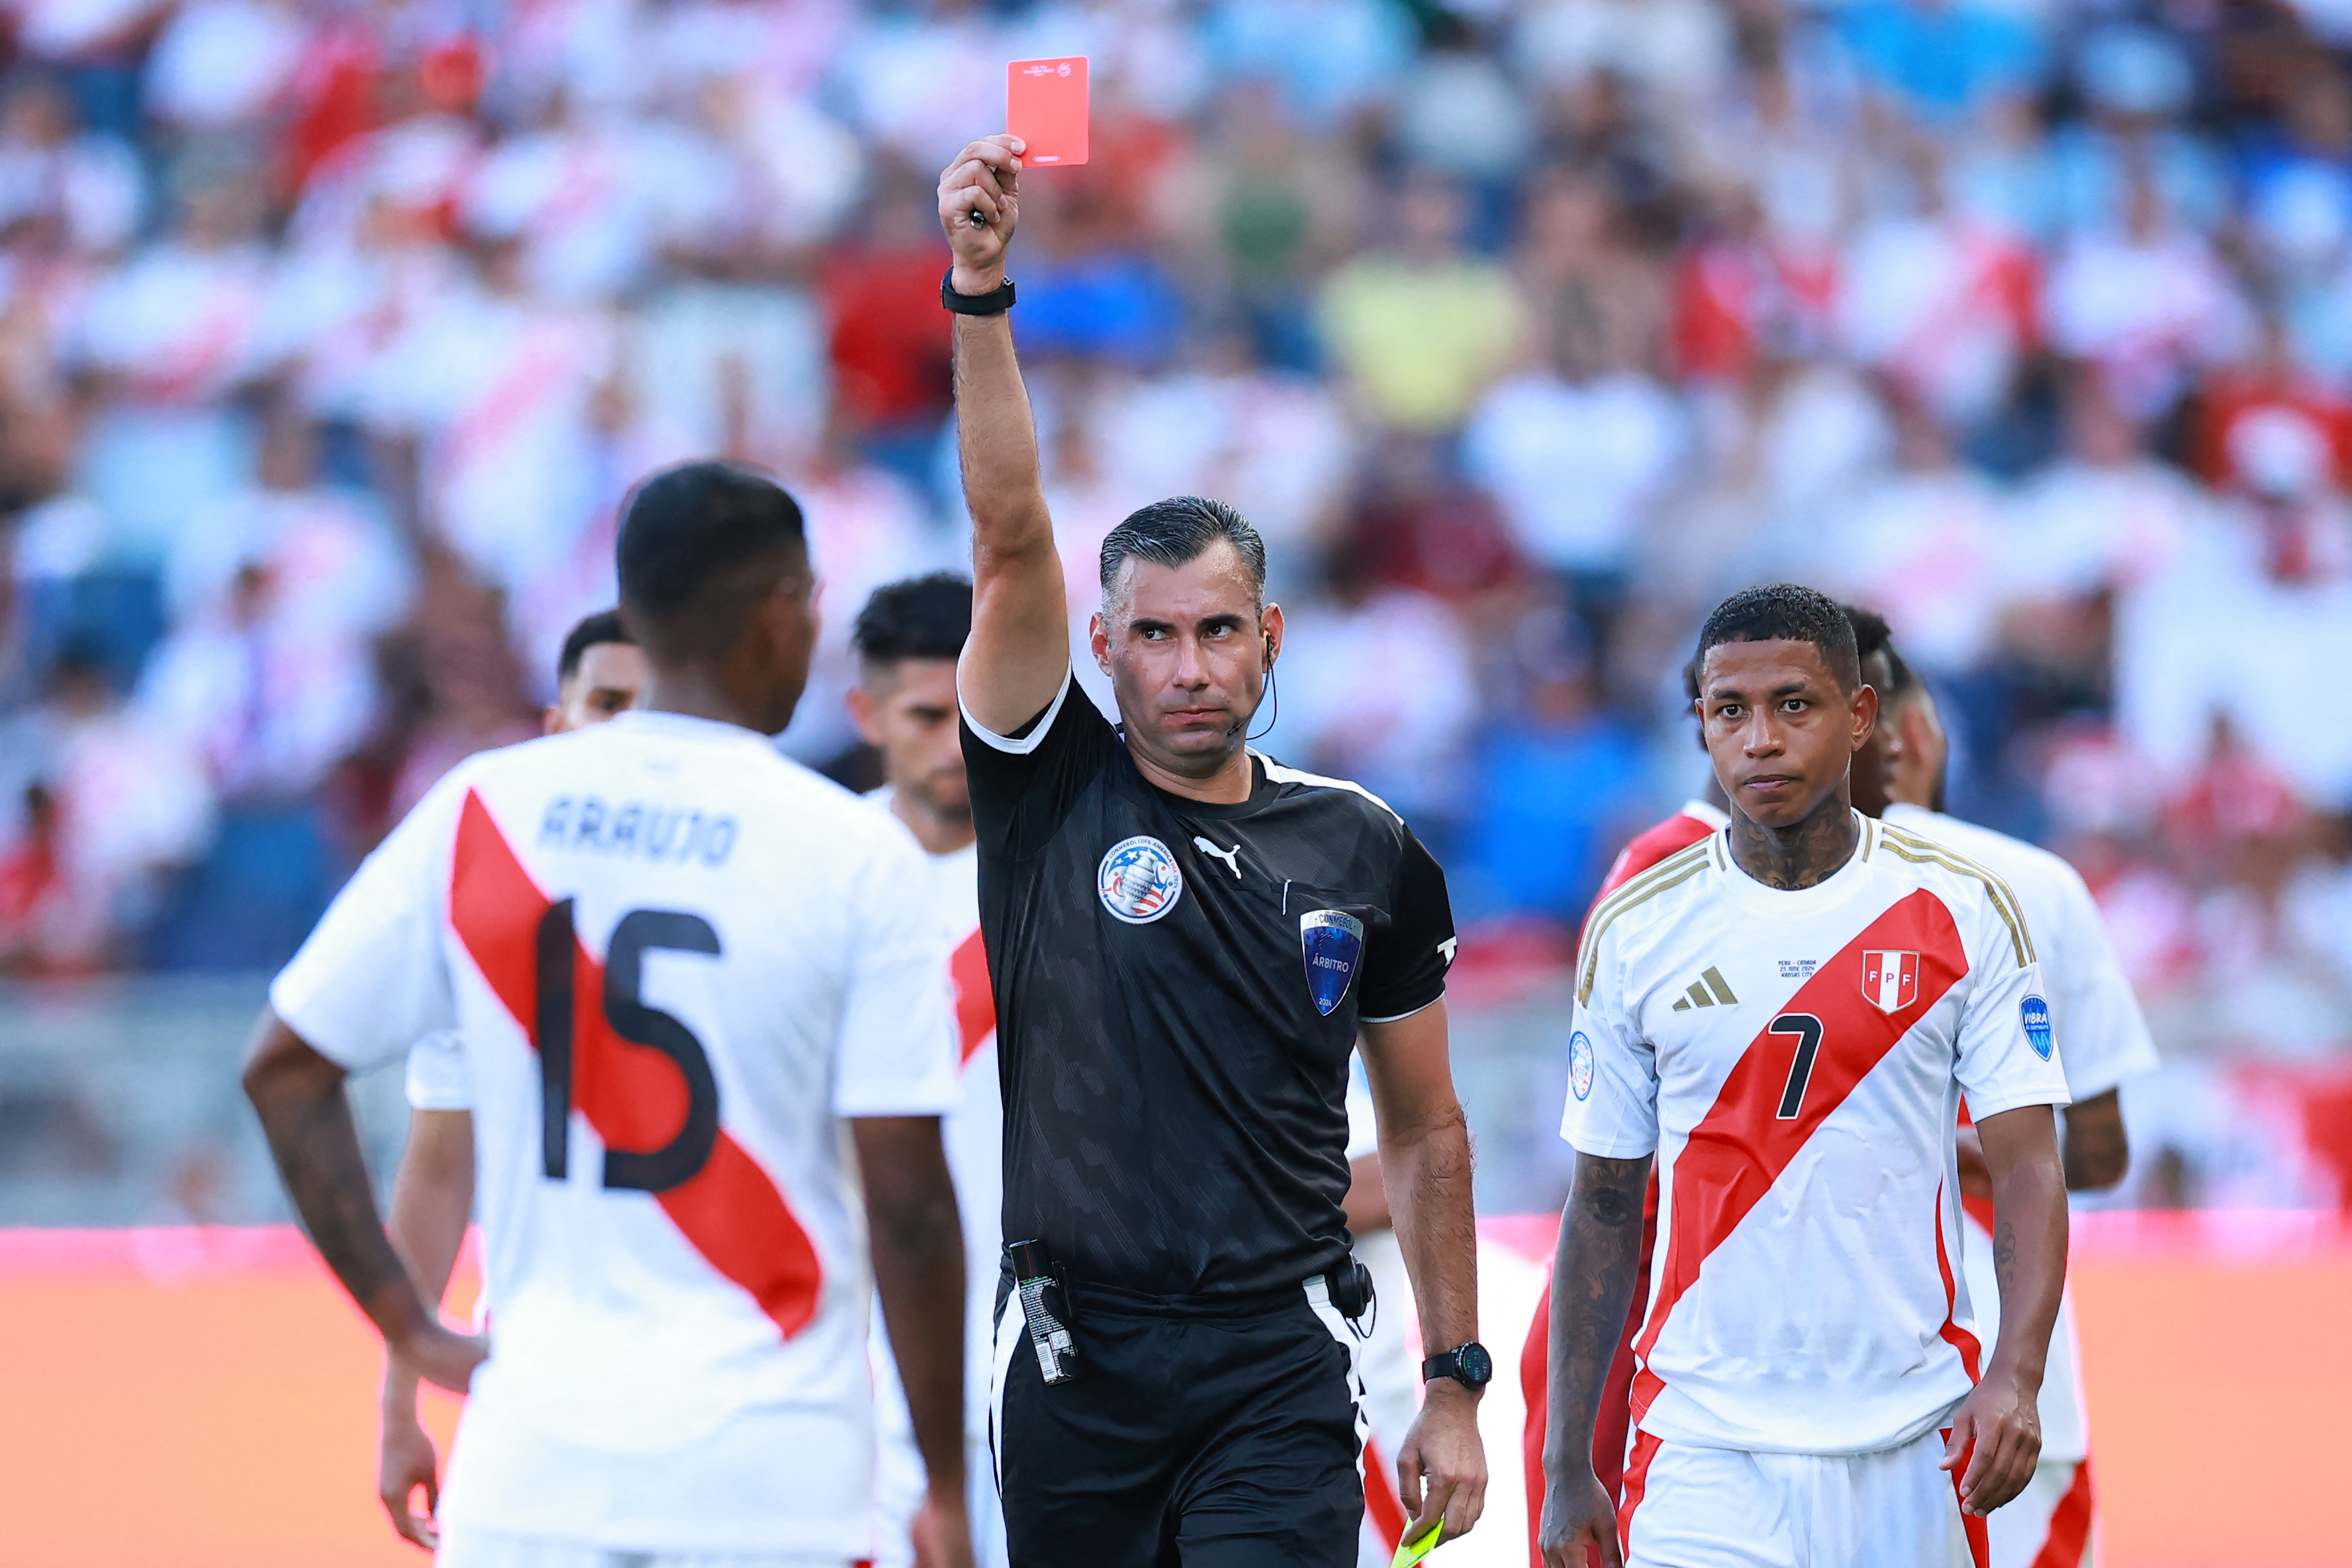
{"left": 849, "top": 1117, "right": 971, "bottom": 1568}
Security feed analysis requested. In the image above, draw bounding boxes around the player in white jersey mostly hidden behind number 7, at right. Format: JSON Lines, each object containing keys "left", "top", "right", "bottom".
{"left": 1846, "top": 606, "right": 2157, "bottom": 1568}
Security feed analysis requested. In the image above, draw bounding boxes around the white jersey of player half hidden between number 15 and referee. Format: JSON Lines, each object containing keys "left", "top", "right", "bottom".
{"left": 866, "top": 788, "right": 1007, "bottom": 1568}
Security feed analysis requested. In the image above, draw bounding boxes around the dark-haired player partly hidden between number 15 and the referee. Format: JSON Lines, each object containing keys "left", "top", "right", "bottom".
{"left": 849, "top": 574, "right": 1007, "bottom": 1568}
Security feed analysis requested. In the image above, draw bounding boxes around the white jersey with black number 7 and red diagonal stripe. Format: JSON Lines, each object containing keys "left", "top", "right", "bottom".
{"left": 1562, "top": 815, "right": 2067, "bottom": 1453}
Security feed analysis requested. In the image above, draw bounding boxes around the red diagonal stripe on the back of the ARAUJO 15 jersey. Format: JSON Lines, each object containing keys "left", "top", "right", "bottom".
{"left": 449, "top": 792, "right": 823, "bottom": 1338}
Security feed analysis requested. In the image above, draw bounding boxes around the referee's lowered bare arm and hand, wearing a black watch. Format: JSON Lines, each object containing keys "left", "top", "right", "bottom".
{"left": 1362, "top": 997, "right": 1486, "bottom": 1540}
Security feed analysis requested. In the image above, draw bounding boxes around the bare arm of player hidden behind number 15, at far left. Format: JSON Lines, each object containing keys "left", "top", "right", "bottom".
{"left": 376, "top": 1109, "right": 473, "bottom": 1551}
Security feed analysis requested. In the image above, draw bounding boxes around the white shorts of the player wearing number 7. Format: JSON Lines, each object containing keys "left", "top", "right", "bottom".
{"left": 1618, "top": 1432, "right": 1985, "bottom": 1568}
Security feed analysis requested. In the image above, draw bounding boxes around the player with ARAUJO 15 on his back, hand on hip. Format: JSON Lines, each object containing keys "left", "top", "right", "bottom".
{"left": 245, "top": 463, "right": 971, "bottom": 1568}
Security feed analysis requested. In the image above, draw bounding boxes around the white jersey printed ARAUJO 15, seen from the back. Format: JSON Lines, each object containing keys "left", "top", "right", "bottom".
{"left": 271, "top": 712, "right": 957, "bottom": 1563}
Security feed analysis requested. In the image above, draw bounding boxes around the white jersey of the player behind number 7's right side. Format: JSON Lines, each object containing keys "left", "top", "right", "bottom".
{"left": 1884, "top": 804, "right": 2157, "bottom": 1476}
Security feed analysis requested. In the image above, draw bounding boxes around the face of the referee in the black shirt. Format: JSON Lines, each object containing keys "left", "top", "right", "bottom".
{"left": 1094, "top": 538, "right": 1282, "bottom": 778}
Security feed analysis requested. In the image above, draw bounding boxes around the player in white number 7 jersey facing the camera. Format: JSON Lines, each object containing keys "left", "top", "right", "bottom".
{"left": 1540, "top": 585, "right": 2067, "bottom": 1568}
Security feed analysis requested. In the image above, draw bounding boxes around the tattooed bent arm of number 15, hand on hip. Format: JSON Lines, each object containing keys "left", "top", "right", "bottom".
{"left": 245, "top": 1011, "right": 487, "bottom": 1392}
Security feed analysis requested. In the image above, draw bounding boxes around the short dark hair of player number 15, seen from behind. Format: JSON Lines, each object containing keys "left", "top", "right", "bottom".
{"left": 614, "top": 463, "right": 807, "bottom": 656}
